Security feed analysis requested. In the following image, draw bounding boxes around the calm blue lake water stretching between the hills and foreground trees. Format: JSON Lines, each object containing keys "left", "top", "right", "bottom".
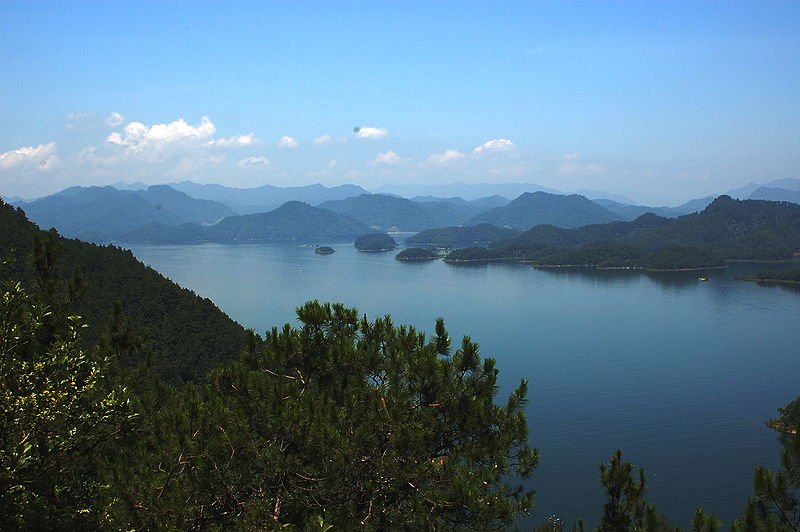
{"left": 126, "top": 244, "right": 800, "bottom": 527}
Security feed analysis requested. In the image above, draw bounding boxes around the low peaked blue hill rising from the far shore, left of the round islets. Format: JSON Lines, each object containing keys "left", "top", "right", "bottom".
{"left": 123, "top": 201, "right": 370, "bottom": 244}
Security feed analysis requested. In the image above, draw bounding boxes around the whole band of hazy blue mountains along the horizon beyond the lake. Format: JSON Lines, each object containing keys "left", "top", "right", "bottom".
{"left": 6, "top": 179, "right": 800, "bottom": 243}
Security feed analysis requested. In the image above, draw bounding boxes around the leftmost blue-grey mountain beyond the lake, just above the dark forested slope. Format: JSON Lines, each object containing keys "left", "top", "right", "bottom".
{"left": 20, "top": 185, "right": 234, "bottom": 242}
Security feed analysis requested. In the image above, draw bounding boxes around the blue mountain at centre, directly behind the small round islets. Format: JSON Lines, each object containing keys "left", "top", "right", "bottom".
{"left": 319, "top": 194, "right": 476, "bottom": 231}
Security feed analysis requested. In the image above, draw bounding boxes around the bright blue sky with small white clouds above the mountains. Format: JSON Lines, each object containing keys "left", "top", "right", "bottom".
{"left": 0, "top": 0, "right": 800, "bottom": 205}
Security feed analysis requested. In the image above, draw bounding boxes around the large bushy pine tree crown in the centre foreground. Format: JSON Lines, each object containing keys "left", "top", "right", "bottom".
{"left": 115, "top": 302, "right": 537, "bottom": 530}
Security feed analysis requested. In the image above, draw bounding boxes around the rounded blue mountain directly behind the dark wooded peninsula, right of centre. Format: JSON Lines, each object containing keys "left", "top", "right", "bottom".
{"left": 464, "top": 192, "right": 620, "bottom": 230}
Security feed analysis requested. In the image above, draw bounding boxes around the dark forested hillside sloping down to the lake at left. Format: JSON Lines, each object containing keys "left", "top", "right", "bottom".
{"left": 0, "top": 197, "right": 248, "bottom": 381}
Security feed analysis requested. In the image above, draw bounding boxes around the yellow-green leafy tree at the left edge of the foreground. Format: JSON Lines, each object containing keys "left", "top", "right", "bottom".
{"left": 0, "top": 266, "right": 132, "bottom": 530}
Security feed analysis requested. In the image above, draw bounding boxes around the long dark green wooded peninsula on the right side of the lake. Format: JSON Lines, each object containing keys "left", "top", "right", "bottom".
{"left": 446, "top": 196, "right": 800, "bottom": 269}
